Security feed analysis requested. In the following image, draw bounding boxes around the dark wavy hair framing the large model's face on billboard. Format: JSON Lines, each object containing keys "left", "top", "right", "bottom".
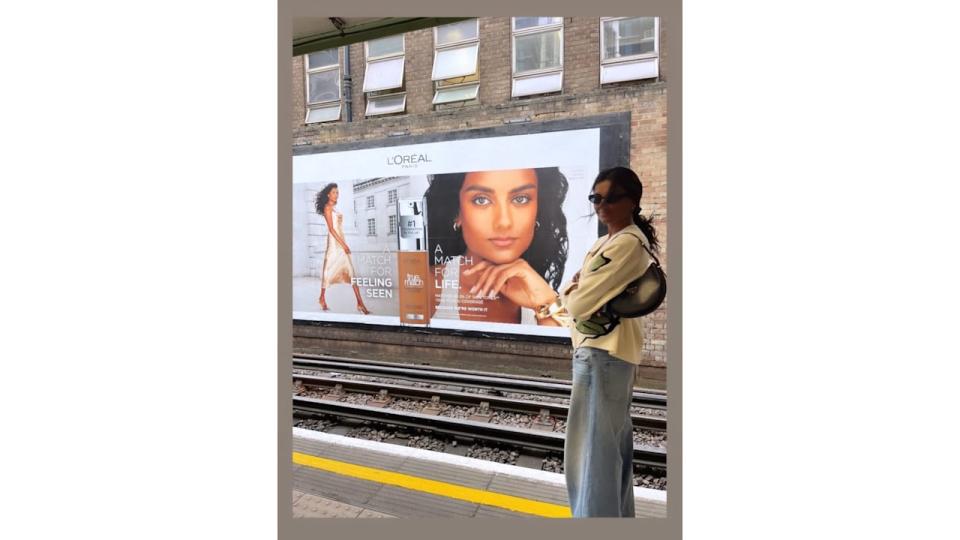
{"left": 424, "top": 167, "right": 569, "bottom": 290}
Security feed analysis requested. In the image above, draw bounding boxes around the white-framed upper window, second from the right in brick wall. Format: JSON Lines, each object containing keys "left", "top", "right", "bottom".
{"left": 511, "top": 17, "right": 563, "bottom": 97}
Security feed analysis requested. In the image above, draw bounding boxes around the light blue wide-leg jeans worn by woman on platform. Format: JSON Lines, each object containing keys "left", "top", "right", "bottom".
{"left": 563, "top": 347, "right": 636, "bottom": 518}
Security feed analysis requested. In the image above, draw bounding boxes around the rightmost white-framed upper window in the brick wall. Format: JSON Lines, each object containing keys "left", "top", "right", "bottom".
{"left": 600, "top": 17, "right": 660, "bottom": 84}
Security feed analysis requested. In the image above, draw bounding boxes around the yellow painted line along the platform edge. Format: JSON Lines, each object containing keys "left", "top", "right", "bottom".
{"left": 293, "top": 452, "right": 572, "bottom": 518}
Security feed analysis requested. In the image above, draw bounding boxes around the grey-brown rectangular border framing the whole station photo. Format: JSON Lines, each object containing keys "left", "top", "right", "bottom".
{"left": 276, "top": 0, "right": 683, "bottom": 540}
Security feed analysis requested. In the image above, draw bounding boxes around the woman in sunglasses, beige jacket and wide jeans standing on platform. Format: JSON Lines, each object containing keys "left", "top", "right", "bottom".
{"left": 552, "top": 167, "right": 659, "bottom": 517}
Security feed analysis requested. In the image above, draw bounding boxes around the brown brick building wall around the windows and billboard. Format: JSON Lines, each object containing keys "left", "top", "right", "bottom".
{"left": 291, "top": 17, "right": 670, "bottom": 380}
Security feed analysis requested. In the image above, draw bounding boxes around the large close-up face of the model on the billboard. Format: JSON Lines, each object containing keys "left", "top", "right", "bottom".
{"left": 460, "top": 169, "right": 537, "bottom": 264}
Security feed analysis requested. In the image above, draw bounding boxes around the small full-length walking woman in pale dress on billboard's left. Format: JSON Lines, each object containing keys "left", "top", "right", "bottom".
{"left": 315, "top": 183, "right": 370, "bottom": 315}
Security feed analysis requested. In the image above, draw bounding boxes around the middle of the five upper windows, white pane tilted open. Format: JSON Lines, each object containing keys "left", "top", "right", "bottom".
{"left": 431, "top": 19, "right": 480, "bottom": 105}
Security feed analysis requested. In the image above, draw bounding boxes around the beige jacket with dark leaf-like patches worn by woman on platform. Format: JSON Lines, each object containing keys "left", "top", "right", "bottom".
{"left": 560, "top": 224, "right": 652, "bottom": 364}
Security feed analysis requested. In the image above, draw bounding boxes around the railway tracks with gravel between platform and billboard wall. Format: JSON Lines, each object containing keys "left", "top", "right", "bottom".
{"left": 292, "top": 355, "right": 667, "bottom": 474}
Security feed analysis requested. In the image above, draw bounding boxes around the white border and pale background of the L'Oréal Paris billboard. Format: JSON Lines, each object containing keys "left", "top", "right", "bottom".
{"left": 293, "top": 128, "right": 600, "bottom": 337}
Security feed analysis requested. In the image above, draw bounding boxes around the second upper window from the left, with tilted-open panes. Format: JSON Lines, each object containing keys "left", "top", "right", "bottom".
{"left": 363, "top": 34, "right": 407, "bottom": 116}
